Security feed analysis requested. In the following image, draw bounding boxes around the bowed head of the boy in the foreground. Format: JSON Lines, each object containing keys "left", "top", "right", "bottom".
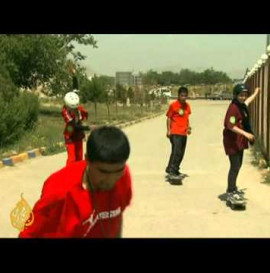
{"left": 86, "top": 126, "right": 130, "bottom": 190}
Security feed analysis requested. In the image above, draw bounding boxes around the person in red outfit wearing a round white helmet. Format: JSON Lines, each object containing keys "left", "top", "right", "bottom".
{"left": 62, "top": 69, "right": 90, "bottom": 165}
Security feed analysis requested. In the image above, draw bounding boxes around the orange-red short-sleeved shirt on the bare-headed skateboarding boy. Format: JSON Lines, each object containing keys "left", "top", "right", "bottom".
{"left": 166, "top": 100, "right": 191, "bottom": 136}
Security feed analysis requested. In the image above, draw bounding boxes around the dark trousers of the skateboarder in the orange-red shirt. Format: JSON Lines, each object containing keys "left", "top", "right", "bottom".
{"left": 166, "top": 135, "right": 187, "bottom": 174}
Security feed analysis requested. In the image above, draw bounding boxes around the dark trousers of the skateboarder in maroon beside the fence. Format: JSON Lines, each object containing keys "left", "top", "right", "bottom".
{"left": 227, "top": 150, "right": 244, "bottom": 192}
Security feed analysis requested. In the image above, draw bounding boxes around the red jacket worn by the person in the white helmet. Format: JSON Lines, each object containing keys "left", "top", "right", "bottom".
{"left": 62, "top": 105, "right": 88, "bottom": 143}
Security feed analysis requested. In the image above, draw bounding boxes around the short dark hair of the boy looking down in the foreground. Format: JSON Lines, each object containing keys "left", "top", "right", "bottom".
{"left": 86, "top": 126, "right": 130, "bottom": 163}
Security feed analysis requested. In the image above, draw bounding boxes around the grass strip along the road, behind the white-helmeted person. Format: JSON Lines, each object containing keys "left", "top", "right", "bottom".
{"left": 0, "top": 103, "right": 167, "bottom": 160}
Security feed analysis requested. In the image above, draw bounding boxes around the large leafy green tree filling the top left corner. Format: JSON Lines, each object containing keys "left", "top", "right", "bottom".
{"left": 0, "top": 34, "right": 97, "bottom": 95}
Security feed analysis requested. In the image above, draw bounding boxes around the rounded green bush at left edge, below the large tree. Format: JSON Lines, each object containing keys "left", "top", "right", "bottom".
{"left": 0, "top": 92, "right": 39, "bottom": 147}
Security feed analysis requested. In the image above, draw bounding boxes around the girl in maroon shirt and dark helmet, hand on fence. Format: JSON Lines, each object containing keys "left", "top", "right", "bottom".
{"left": 223, "top": 84, "right": 260, "bottom": 200}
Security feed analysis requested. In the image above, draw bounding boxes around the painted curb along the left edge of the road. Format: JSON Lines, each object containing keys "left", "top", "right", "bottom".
{"left": 0, "top": 112, "right": 164, "bottom": 169}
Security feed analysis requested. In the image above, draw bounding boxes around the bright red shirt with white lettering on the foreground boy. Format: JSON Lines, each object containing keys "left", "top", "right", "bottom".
{"left": 19, "top": 161, "right": 132, "bottom": 238}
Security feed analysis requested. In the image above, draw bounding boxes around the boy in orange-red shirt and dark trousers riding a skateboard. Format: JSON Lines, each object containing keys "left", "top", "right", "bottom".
{"left": 166, "top": 87, "right": 191, "bottom": 179}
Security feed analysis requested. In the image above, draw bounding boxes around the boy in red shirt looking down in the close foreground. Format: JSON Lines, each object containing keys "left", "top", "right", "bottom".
{"left": 19, "top": 126, "right": 132, "bottom": 238}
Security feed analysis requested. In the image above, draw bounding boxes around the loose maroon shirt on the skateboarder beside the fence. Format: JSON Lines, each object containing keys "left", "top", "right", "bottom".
{"left": 223, "top": 103, "right": 248, "bottom": 155}
